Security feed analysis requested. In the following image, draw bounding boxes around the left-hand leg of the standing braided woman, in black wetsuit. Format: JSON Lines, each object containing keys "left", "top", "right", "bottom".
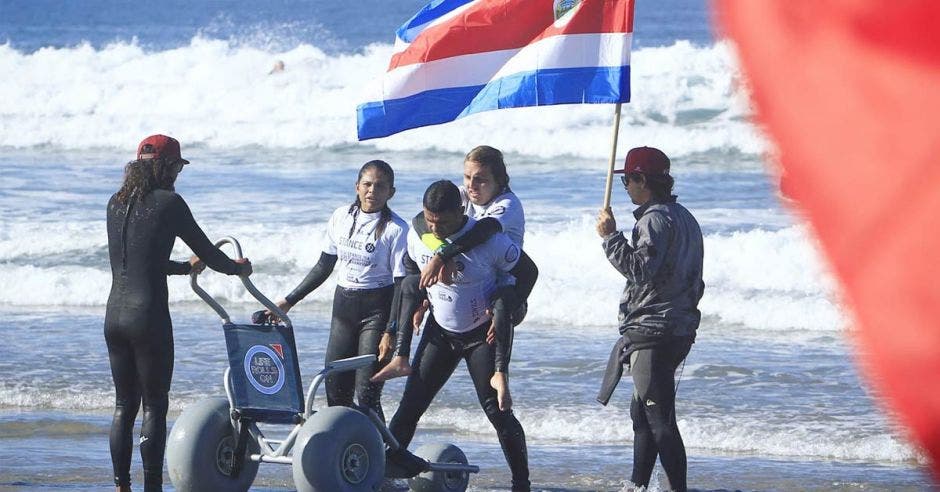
{"left": 326, "top": 286, "right": 359, "bottom": 407}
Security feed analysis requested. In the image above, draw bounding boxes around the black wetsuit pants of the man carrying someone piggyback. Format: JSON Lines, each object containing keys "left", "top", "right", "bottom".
{"left": 389, "top": 315, "right": 529, "bottom": 490}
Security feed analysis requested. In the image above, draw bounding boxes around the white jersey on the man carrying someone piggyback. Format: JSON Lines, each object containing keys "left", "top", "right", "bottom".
{"left": 408, "top": 217, "right": 521, "bottom": 333}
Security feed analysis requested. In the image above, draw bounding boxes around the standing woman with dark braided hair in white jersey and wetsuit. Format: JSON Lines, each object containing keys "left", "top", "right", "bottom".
{"left": 270, "top": 160, "right": 408, "bottom": 420}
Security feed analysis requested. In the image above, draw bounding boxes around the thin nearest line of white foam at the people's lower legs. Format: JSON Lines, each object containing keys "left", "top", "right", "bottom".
{"left": 0, "top": 386, "right": 926, "bottom": 463}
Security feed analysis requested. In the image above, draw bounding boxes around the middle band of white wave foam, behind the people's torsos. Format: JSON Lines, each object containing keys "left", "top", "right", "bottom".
{"left": 0, "top": 217, "right": 845, "bottom": 332}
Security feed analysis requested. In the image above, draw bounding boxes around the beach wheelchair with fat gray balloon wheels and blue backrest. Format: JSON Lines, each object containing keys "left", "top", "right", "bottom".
{"left": 167, "top": 237, "right": 479, "bottom": 492}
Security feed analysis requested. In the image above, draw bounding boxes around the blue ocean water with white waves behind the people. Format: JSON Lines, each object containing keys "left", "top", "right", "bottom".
{"left": 0, "top": 0, "right": 932, "bottom": 491}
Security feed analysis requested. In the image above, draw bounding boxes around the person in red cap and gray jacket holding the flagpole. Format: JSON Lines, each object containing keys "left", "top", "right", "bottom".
{"left": 597, "top": 147, "right": 705, "bottom": 491}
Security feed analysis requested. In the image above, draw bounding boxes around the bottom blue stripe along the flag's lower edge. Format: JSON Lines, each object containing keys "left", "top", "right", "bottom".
{"left": 356, "top": 65, "right": 630, "bottom": 140}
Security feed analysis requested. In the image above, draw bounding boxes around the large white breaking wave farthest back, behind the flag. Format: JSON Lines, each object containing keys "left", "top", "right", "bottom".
{"left": 0, "top": 37, "right": 765, "bottom": 158}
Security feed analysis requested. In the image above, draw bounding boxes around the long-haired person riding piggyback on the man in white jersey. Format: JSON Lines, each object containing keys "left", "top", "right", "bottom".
{"left": 376, "top": 145, "right": 526, "bottom": 410}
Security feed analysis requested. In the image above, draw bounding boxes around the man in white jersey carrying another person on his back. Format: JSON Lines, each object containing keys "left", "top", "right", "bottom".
{"left": 378, "top": 180, "right": 538, "bottom": 491}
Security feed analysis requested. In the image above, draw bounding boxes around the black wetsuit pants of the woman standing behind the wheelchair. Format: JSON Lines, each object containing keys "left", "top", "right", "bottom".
{"left": 326, "top": 286, "right": 394, "bottom": 421}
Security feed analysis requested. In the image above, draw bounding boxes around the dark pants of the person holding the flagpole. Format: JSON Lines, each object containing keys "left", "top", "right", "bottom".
{"left": 630, "top": 338, "right": 692, "bottom": 492}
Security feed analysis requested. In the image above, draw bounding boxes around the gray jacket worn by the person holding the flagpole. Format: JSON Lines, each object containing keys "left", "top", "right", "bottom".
{"left": 604, "top": 196, "right": 705, "bottom": 337}
